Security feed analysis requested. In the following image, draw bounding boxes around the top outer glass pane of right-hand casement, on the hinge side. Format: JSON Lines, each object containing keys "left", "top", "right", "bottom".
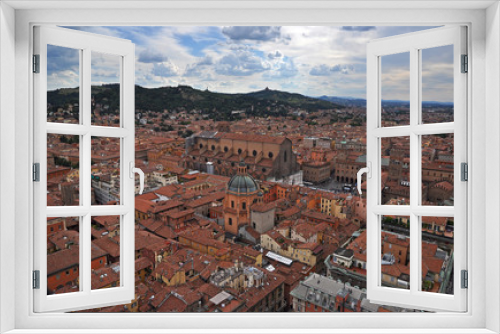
{"left": 421, "top": 45, "right": 453, "bottom": 123}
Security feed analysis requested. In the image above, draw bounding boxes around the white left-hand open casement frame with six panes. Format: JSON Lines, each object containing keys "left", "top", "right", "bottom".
{"left": 33, "top": 25, "right": 135, "bottom": 312}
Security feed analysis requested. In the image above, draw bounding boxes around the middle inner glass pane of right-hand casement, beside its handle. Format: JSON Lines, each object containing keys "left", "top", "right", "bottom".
{"left": 381, "top": 137, "right": 410, "bottom": 205}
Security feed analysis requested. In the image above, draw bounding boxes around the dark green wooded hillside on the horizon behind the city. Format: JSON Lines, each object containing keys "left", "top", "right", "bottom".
{"left": 47, "top": 84, "right": 343, "bottom": 120}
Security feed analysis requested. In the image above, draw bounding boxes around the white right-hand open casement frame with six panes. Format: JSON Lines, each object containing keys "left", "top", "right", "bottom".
{"left": 366, "top": 25, "right": 466, "bottom": 312}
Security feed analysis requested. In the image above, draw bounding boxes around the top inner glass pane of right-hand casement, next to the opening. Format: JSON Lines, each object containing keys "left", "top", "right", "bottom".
{"left": 380, "top": 52, "right": 410, "bottom": 126}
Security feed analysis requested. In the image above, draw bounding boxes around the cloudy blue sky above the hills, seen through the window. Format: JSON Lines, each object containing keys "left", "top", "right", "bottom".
{"left": 48, "top": 26, "right": 453, "bottom": 101}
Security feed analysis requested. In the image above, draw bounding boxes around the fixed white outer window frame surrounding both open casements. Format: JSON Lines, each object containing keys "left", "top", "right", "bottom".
{"left": 0, "top": 1, "right": 500, "bottom": 333}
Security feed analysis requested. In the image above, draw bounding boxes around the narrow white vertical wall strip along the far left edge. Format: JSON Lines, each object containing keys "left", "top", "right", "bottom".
{"left": 0, "top": 2, "right": 15, "bottom": 333}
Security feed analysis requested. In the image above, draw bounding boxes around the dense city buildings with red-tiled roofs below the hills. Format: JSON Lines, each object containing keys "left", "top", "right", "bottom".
{"left": 47, "top": 92, "right": 453, "bottom": 312}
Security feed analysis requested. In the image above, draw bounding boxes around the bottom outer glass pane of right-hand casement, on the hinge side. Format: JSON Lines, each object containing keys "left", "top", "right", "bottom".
{"left": 422, "top": 217, "right": 454, "bottom": 294}
